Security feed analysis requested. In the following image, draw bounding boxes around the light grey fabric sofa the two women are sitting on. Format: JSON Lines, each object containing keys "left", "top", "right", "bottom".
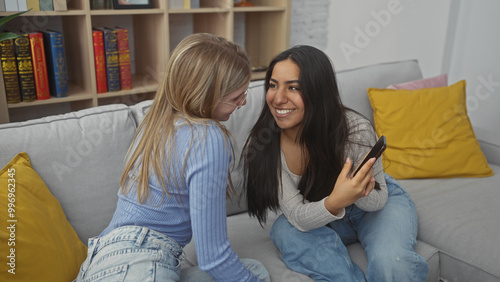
{"left": 0, "top": 60, "right": 500, "bottom": 281}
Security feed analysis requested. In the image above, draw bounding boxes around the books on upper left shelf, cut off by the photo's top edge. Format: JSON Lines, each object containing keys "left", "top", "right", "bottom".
{"left": 0, "top": 0, "right": 68, "bottom": 12}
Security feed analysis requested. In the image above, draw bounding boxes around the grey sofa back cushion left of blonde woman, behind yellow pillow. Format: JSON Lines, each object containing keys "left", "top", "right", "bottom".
{"left": 0, "top": 105, "right": 136, "bottom": 243}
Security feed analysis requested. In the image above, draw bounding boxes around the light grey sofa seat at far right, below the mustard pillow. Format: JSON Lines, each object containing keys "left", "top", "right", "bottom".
{"left": 400, "top": 165, "right": 500, "bottom": 281}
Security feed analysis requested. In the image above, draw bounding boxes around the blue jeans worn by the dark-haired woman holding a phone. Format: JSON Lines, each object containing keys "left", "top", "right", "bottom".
{"left": 271, "top": 174, "right": 429, "bottom": 282}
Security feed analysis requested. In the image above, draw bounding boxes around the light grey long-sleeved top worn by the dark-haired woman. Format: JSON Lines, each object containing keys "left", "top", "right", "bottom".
{"left": 279, "top": 111, "right": 387, "bottom": 231}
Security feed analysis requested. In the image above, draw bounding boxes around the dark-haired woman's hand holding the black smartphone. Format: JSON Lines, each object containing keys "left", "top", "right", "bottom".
{"left": 325, "top": 158, "right": 376, "bottom": 215}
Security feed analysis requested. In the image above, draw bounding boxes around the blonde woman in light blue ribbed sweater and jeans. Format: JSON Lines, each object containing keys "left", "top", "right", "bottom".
{"left": 76, "top": 34, "right": 270, "bottom": 281}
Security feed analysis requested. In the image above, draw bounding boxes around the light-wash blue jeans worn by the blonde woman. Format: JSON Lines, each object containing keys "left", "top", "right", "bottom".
{"left": 74, "top": 226, "right": 269, "bottom": 282}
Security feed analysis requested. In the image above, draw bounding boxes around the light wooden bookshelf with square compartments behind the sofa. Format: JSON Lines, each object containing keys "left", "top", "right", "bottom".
{"left": 0, "top": 0, "right": 291, "bottom": 123}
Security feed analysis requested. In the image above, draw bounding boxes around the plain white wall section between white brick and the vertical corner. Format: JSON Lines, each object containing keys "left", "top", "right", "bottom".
{"left": 325, "top": 0, "right": 450, "bottom": 77}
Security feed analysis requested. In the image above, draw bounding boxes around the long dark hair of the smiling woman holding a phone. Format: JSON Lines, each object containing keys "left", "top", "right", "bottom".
{"left": 242, "top": 46, "right": 349, "bottom": 222}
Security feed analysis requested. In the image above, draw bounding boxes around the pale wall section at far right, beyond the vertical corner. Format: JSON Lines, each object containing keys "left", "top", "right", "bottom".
{"left": 448, "top": 0, "right": 500, "bottom": 131}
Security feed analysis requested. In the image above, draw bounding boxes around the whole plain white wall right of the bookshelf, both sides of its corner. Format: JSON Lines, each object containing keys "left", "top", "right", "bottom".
{"left": 316, "top": 0, "right": 500, "bottom": 134}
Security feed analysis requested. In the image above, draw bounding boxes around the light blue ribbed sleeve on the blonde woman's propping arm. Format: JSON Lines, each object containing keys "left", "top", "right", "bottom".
{"left": 185, "top": 125, "right": 259, "bottom": 281}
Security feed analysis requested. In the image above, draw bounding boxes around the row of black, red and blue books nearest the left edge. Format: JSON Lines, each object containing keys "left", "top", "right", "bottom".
{"left": 0, "top": 30, "right": 68, "bottom": 103}
